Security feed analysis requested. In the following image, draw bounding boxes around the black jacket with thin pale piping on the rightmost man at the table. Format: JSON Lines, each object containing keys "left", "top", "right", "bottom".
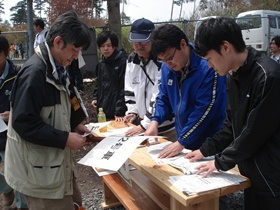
{"left": 200, "top": 48, "right": 280, "bottom": 196}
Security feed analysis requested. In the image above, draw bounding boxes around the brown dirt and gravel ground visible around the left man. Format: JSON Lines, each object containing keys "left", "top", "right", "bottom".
{"left": 0, "top": 82, "right": 102, "bottom": 210}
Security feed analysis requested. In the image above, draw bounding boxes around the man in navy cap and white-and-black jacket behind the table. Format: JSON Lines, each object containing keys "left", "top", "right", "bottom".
{"left": 124, "top": 18, "right": 177, "bottom": 141}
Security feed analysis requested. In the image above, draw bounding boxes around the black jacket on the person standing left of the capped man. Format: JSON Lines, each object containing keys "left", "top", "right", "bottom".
{"left": 93, "top": 50, "right": 127, "bottom": 119}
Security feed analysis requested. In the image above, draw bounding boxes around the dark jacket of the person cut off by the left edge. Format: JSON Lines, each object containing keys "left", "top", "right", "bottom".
{"left": 0, "top": 59, "right": 17, "bottom": 151}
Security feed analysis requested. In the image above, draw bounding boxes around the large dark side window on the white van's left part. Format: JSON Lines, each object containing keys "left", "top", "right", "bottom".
{"left": 236, "top": 15, "right": 262, "bottom": 30}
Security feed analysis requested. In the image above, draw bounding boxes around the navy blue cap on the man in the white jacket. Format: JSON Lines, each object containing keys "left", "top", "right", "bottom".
{"left": 128, "top": 18, "right": 155, "bottom": 42}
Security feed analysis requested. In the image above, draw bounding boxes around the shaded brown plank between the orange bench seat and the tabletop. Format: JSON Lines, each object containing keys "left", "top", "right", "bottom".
{"left": 130, "top": 170, "right": 170, "bottom": 210}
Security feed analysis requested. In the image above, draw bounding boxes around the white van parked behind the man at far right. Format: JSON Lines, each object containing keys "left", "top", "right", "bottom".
{"left": 236, "top": 10, "right": 280, "bottom": 55}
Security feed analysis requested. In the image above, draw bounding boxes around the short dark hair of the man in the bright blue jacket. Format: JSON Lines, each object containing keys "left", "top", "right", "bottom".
{"left": 151, "top": 24, "right": 188, "bottom": 56}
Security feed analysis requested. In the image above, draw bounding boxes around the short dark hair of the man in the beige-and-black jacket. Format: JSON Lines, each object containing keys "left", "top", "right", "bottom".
{"left": 46, "top": 11, "right": 91, "bottom": 50}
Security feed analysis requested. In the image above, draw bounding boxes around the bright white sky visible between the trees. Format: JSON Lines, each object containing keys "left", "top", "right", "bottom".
{"left": 1, "top": 0, "right": 199, "bottom": 22}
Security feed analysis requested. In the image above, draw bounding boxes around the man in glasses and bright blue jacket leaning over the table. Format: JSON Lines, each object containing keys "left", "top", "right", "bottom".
{"left": 145, "top": 24, "right": 226, "bottom": 158}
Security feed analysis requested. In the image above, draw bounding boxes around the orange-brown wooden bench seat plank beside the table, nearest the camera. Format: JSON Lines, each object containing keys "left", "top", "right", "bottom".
{"left": 102, "top": 174, "right": 161, "bottom": 210}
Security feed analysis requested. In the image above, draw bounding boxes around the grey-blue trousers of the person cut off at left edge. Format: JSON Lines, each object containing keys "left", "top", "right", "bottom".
{"left": 0, "top": 151, "right": 28, "bottom": 208}
